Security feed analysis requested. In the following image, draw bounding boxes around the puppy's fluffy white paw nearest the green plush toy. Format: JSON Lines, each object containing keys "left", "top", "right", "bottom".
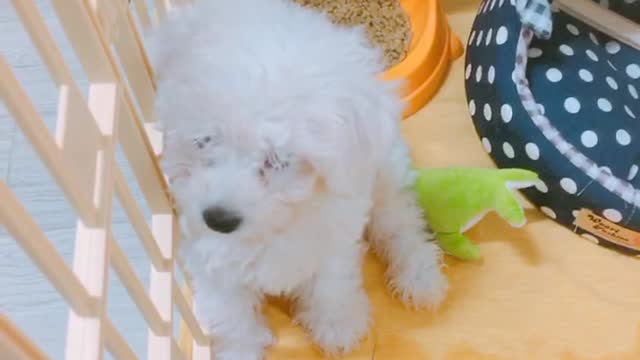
{"left": 389, "top": 243, "right": 449, "bottom": 308}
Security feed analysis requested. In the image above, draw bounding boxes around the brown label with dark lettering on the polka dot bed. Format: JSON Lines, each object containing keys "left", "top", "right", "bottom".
{"left": 574, "top": 209, "right": 640, "bottom": 250}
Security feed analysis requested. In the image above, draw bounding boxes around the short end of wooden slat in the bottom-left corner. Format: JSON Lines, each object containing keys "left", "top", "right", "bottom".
{"left": 0, "top": 314, "right": 49, "bottom": 360}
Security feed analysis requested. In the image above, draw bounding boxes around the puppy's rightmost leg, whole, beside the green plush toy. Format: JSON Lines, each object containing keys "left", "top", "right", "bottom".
{"left": 368, "top": 143, "right": 448, "bottom": 307}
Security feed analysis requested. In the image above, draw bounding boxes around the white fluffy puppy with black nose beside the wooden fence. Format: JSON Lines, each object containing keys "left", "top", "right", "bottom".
{"left": 150, "top": 0, "right": 447, "bottom": 359}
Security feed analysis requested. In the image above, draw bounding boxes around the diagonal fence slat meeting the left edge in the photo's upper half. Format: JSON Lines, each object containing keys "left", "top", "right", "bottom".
{"left": 0, "top": 56, "right": 96, "bottom": 224}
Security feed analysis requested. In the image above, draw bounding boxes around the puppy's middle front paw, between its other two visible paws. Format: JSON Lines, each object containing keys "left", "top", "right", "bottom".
{"left": 298, "top": 291, "right": 369, "bottom": 355}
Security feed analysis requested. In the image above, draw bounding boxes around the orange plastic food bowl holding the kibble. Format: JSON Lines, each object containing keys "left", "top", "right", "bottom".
{"left": 382, "top": 0, "right": 464, "bottom": 118}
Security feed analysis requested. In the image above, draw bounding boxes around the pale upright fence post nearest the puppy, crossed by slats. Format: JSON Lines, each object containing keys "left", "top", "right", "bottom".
{"left": 147, "top": 213, "right": 176, "bottom": 360}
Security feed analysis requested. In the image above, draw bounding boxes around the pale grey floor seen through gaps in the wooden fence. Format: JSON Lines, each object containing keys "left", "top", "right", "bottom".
{"left": 0, "top": 0, "right": 159, "bottom": 359}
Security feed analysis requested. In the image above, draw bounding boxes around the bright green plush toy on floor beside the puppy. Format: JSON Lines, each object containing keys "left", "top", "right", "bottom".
{"left": 415, "top": 168, "right": 538, "bottom": 260}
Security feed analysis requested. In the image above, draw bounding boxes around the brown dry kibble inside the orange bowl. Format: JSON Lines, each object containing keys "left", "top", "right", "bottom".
{"left": 293, "top": 0, "right": 411, "bottom": 68}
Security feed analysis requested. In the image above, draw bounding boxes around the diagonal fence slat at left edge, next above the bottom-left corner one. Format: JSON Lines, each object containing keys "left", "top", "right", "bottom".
{"left": 0, "top": 181, "right": 97, "bottom": 315}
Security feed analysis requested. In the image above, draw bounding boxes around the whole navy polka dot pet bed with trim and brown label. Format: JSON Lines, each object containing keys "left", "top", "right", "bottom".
{"left": 465, "top": 0, "right": 640, "bottom": 255}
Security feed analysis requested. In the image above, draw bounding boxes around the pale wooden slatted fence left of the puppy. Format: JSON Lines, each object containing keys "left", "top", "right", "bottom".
{"left": 0, "top": 0, "right": 210, "bottom": 360}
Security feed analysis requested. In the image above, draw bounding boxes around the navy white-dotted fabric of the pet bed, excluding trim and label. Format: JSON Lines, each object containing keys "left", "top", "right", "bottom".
{"left": 465, "top": 0, "right": 640, "bottom": 255}
